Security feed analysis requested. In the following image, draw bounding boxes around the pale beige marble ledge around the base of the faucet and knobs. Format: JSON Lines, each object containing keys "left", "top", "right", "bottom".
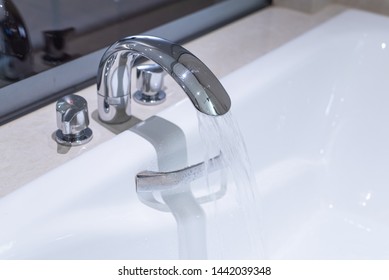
{"left": 0, "top": 5, "right": 345, "bottom": 197}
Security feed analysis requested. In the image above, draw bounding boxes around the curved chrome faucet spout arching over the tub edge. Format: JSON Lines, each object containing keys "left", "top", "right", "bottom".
{"left": 97, "top": 36, "right": 231, "bottom": 123}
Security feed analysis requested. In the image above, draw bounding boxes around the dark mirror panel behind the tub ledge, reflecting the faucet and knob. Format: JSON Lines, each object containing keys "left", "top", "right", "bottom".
{"left": 0, "top": 0, "right": 221, "bottom": 86}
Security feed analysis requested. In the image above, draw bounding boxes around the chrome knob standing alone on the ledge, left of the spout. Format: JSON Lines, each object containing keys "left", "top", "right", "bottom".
{"left": 55, "top": 95, "right": 92, "bottom": 146}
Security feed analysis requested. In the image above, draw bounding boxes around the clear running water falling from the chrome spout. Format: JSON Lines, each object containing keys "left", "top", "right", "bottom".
{"left": 198, "top": 112, "right": 264, "bottom": 259}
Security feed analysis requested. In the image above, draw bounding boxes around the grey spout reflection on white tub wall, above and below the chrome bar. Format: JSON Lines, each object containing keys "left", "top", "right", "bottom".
{"left": 132, "top": 116, "right": 207, "bottom": 259}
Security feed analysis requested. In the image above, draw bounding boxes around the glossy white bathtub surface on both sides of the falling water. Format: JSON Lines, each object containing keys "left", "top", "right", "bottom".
{"left": 0, "top": 11, "right": 389, "bottom": 259}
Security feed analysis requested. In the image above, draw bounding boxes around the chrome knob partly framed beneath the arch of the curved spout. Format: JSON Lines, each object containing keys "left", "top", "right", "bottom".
{"left": 134, "top": 64, "right": 166, "bottom": 105}
